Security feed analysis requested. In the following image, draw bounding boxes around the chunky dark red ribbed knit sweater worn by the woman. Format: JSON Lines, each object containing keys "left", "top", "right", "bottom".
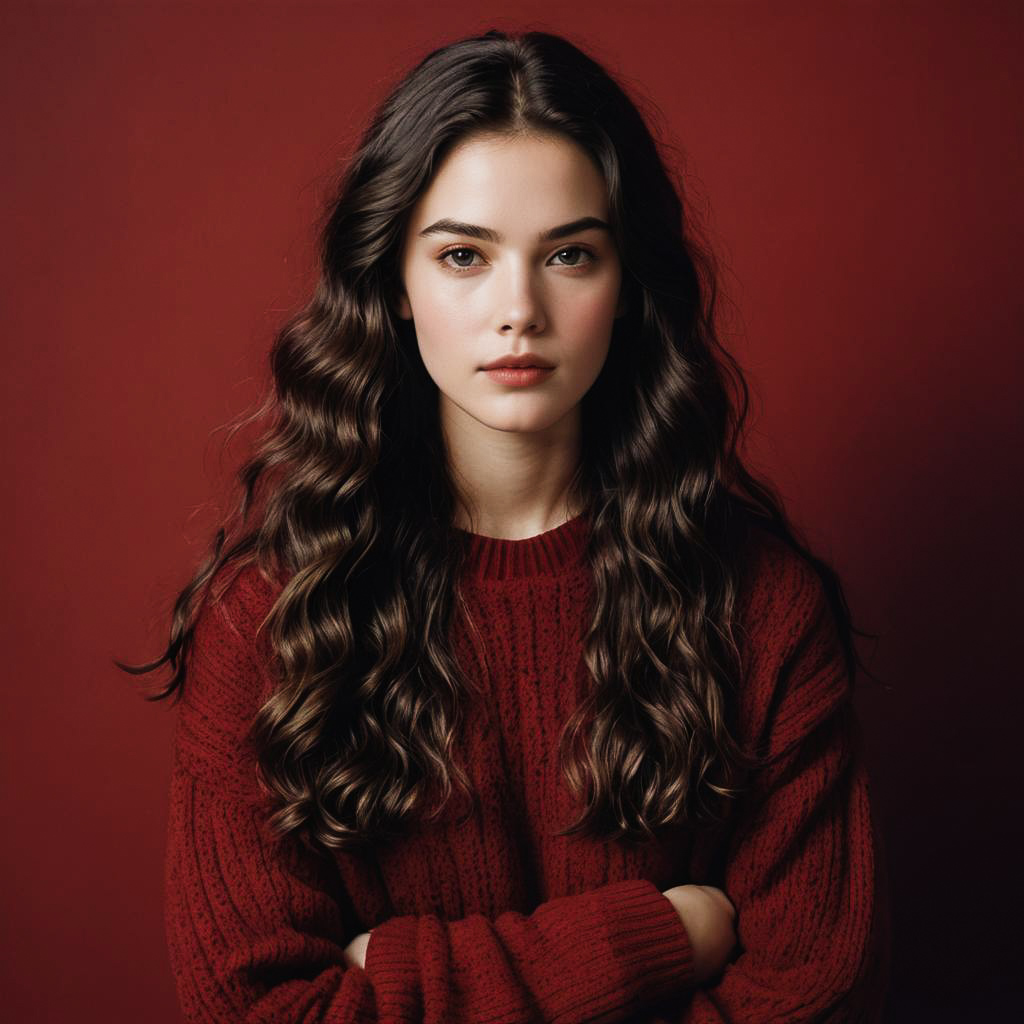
{"left": 165, "top": 515, "right": 889, "bottom": 1024}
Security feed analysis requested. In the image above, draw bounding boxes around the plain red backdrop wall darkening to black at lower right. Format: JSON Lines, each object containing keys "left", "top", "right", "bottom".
{"left": 0, "top": 2, "right": 1024, "bottom": 1024}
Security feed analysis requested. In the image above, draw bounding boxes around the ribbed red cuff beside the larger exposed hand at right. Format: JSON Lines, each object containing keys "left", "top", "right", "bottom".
{"left": 600, "top": 879, "right": 693, "bottom": 1002}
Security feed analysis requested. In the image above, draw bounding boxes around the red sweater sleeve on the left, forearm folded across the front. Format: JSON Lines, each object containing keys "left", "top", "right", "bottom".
{"left": 165, "top": 577, "right": 692, "bottom": 1024}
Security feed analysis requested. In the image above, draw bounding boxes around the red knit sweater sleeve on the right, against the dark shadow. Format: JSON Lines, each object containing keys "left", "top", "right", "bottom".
{"left": 644, "top": 567, "right": 889, "bottom": 1024}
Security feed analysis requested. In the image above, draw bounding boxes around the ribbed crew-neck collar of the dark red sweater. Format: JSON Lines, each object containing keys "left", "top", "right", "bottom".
{"left": 456, "top": 512, "right": 590, "bottom": 580}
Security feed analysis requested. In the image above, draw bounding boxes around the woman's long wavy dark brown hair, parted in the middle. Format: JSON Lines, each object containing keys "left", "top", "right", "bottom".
{"left": 117, "top": 30, "right": 866, "bottom": 849}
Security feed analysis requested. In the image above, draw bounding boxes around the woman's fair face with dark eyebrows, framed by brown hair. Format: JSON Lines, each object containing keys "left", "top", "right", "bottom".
{"left": 398, "top": 135, "right": 622, "bottom": 440}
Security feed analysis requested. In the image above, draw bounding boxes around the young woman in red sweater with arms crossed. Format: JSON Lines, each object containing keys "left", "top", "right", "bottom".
{"left": 126, "top": 31, "right": 887, "bottom": 1024}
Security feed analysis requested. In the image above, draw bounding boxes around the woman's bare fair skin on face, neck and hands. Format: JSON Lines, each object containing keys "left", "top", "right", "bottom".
{"left": 345, "top": 135, "right": 736, "bottom": 983}
